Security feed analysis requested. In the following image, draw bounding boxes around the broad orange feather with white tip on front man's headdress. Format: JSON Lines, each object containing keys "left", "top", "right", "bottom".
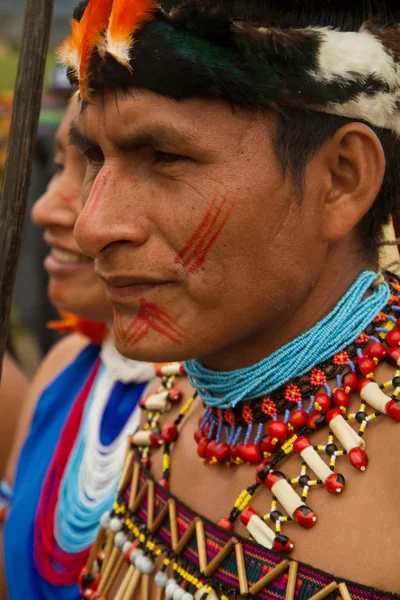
{"left": 106, "top": 0, "right": 159, "bottom": 70}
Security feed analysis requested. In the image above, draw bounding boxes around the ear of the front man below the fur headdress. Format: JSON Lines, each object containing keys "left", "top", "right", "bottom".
{"left": 320, "top": 122, "right": 386, "bottom": 243}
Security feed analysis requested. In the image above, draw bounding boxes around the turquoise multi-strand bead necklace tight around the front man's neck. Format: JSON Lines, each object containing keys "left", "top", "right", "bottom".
{"left": 185, "top": 271, "right": 390, "bottom": 409}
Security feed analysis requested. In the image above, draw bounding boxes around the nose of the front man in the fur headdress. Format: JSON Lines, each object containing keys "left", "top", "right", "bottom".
{"left": 74, "top": 167, "right": 149, "bottom": 258}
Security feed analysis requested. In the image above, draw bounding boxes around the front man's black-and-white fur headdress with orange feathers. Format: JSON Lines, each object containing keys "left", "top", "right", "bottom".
{"left": 58, "top": 0, "right": 400, "bottom": 137}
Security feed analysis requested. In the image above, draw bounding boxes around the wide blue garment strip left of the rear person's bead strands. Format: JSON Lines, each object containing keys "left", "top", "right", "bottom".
{"left": 4, "top": 345, "right": 100, "bottom": 600}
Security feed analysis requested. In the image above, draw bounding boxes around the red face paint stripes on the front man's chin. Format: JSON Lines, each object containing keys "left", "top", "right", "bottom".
{"left": 114, "top": 298, "right": 183, "bottom": 347}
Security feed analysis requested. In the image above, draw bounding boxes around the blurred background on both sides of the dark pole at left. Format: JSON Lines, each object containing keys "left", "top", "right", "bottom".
{"left": 0, "top": 0, "right": 75, "bottom": 376}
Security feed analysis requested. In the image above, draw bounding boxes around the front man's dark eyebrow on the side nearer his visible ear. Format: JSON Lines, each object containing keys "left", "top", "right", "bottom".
{"left": 111, "top": 125, "right": 196, "bottom": 153}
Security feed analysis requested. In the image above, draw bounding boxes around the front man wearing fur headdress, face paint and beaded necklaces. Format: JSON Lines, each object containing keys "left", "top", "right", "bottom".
{"left": 62, "top": 0, "right": 400, "bottom": 600}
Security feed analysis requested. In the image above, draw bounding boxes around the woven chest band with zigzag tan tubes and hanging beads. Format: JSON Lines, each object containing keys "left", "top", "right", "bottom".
{"left": 81, "top": 456, "right": 400, "bottom": 600}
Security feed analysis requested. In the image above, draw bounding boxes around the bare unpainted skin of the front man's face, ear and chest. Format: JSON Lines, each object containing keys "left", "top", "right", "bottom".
{"left": 73, "top": 90, "right": 400, "bottom": 597}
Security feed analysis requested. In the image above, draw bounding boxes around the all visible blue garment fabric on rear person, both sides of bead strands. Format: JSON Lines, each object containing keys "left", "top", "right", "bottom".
{"left": 4, "top": 345, "right": 146, "bottom": 600}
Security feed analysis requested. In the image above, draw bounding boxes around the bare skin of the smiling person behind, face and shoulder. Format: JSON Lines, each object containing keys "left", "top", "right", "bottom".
{"left": 0, "top": 100, "right": 112, "bottom": 598}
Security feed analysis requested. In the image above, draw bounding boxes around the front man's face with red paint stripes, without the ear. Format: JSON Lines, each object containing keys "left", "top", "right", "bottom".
{"left": 72, "top": 90, "right": 326, "bottom": 368}
